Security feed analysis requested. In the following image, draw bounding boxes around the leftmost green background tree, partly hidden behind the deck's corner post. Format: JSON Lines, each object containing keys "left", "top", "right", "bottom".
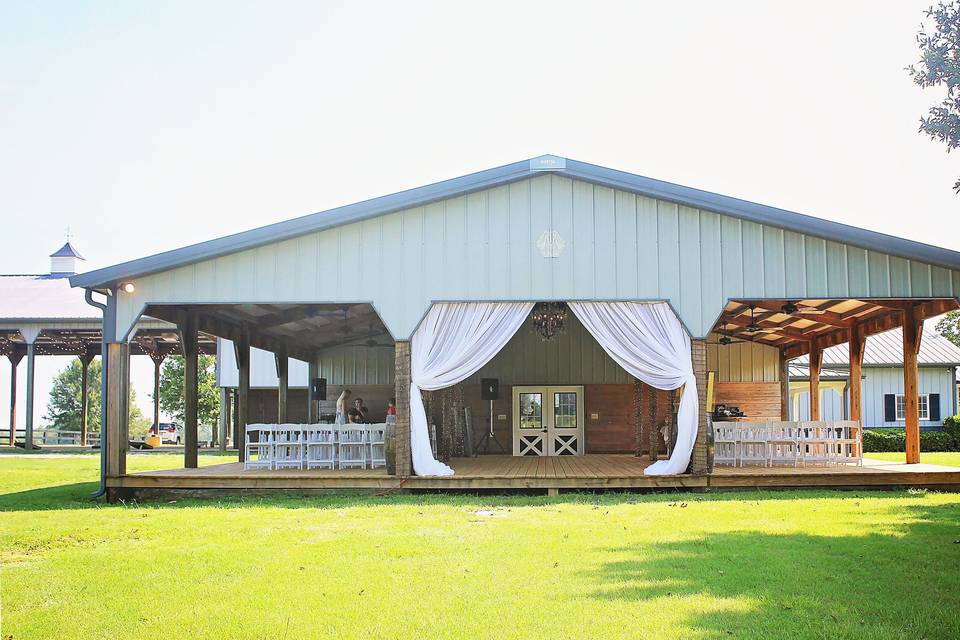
{"left": 44, "top": 358, "right": 150, "bottom": 435}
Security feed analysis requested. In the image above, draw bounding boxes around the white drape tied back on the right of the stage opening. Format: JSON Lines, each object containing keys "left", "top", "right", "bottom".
{"left": 569, "top": 302, "right": 700, "bottom": 475}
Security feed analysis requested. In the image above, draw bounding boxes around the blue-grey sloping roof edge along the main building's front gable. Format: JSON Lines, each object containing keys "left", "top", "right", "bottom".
{"left": 70, "top": 155, "right": 960, "bottom": 288}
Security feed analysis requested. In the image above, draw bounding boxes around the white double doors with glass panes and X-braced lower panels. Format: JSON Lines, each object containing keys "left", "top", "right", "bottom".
{"left": 513, "top": 386, "right": 584, "bottom": 456}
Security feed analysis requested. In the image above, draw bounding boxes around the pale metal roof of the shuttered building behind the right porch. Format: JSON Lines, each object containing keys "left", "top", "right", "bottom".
{"left": 791, "top": 329, "right": 960, "bottom": 368}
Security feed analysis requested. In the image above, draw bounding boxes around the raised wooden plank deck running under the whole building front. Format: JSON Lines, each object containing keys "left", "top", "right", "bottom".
{"left": 108, "top": 455, "right": 960, "bottom": 491}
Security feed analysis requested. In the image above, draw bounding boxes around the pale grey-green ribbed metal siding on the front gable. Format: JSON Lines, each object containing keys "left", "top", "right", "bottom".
{"left": 117, "top": 175, "right": 960, "bottom": 338}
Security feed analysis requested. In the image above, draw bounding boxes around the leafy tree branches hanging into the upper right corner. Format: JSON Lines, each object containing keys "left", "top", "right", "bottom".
{"left": 907, "top": 2, "right": 960, "bottom": 193}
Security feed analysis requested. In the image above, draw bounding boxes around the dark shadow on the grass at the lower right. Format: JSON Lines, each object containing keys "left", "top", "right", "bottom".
{"left": 589, "top": 502, "right": 960, "bottom": 638}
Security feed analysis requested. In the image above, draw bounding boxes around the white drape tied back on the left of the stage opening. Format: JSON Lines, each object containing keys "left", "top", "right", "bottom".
{"left": 410, "top": 302, "right": 533, "bottom": 476}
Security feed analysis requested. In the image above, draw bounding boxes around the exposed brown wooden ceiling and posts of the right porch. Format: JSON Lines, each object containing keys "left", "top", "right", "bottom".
{"left": 714, "top": 298, "right": 960, "bottom": 462}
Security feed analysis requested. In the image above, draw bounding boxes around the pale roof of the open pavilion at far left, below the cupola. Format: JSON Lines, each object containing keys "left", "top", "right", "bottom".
{"left": 0, "top": 275, "right": 102, "bottom": 324}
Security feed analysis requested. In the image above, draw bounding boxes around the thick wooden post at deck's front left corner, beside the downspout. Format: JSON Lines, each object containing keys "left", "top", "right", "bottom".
{"left": 102, "top": 342, "right": 130, "bottom": 478}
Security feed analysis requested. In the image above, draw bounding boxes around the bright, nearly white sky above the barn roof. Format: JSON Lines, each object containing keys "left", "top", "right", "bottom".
{"left": 0, "top": 0, "right": 960, "bottom": 428}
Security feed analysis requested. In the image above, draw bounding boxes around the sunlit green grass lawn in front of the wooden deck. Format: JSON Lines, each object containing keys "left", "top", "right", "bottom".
{"left": 0, "top": 456, "right": 960, "bottom": 640}
